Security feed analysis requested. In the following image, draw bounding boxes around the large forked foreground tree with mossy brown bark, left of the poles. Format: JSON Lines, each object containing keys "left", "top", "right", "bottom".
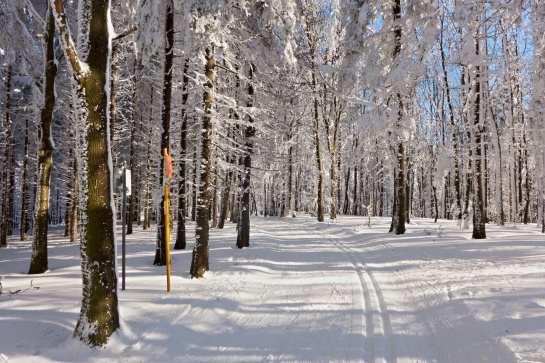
{"left": 50, "top": 0, "right": 119, "bottom": 346}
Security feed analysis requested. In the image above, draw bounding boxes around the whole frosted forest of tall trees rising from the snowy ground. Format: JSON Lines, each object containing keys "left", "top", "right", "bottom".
{"left": 0, "top": 0, "right": 545, "bottom": 352}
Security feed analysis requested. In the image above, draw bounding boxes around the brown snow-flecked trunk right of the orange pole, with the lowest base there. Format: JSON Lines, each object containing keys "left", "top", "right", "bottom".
{"left": 190, "top": 46, "right": 216, "bottom": 278}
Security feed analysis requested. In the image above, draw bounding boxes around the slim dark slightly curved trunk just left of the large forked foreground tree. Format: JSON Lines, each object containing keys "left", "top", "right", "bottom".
{"left": 28, "top": 6, "right": 57, "bottom": 274}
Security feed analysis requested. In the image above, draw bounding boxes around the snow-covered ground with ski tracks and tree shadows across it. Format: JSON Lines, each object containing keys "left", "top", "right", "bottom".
{"left": 0, "top": 216, "right": 545, "bottom": 363}
